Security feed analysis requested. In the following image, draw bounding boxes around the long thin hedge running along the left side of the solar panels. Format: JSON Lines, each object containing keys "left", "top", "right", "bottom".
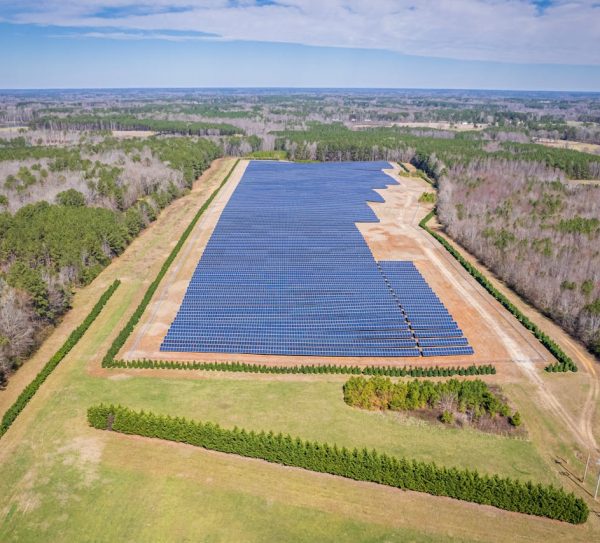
{"left": 102, "top": 159, "right": 239, "bottom": 368}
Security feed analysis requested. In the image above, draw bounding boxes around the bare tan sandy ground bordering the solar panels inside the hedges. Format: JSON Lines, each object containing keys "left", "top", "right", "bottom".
{"left": 120, "top": 161, "right": 546, "bottom": 372}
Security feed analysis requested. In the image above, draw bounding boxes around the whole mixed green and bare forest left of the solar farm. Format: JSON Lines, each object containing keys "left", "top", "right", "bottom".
{"left": 0, "top": 133, "right": 222, "bottom": 382}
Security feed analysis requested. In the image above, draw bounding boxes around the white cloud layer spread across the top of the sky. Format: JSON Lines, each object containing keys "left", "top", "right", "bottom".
{"left": 0, "top": 0, "right": 600, "bottom": 65}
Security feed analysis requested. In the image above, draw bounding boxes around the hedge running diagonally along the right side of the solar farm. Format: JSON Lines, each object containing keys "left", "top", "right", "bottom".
{"left": 419, "top": 210, "right": 577, "bottom": 372}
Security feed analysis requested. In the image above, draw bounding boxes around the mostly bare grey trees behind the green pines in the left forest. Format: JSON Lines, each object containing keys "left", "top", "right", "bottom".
{"left": 0, "top": 137, "right": 222, "bottom": 211}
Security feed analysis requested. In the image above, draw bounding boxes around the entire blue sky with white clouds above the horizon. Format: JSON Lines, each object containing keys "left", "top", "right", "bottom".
{"left": 0, "top": 0, "right": 600, "bottom": 91}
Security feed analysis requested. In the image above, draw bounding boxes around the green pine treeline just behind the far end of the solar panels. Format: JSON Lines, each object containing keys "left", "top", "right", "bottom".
{"left": 275, "top": 123, "right": 600, "bottom": 179}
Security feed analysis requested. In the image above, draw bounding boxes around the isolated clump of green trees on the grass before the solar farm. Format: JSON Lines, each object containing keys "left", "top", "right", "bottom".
{"left": 344, "top": 376, "right": 509, "bottom": 419}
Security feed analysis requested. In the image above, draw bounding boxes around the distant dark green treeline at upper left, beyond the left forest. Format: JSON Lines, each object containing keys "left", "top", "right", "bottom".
{"left": 29, "top": 113, "right": 244, "bottom": 136}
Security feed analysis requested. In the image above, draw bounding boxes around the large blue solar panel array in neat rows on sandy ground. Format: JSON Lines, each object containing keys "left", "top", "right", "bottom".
{"left": 161, "top": 161, "right": 472, "bottom": 357}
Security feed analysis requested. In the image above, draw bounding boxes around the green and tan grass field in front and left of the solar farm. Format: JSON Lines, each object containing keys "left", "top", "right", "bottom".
{"left": 0, "top": 156, "right": 599, "bottom": 542}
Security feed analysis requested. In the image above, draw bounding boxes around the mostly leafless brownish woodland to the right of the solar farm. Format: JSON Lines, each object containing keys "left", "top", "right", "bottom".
{"left": 438, "top": 160, "right": 600, "bottom": 360}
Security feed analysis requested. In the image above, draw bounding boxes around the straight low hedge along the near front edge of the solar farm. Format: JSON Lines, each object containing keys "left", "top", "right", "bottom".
{"left": 110, "top": 358, "right": 496, "bottom": 377}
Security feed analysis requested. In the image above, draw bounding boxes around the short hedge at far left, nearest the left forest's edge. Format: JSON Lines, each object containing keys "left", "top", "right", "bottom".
{"left": 0, "top": 279, "right": 121, "bottom": 437}
